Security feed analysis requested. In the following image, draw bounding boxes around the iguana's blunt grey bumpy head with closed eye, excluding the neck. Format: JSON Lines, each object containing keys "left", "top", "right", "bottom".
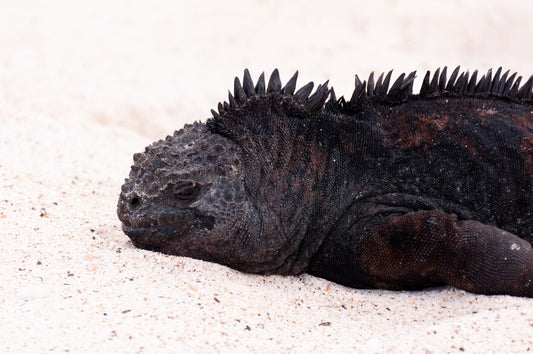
{"left": 118, "top": 123, "right": 245, "bottom": 261}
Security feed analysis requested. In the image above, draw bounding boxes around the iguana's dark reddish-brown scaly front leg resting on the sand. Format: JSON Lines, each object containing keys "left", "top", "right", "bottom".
{"left": 359, "top": 210, "right": 533, "bottom": 297}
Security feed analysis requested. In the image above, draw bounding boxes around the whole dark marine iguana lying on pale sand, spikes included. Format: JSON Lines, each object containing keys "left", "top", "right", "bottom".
{"left": 118, "top": 67, "right": 533, "bottom": 297}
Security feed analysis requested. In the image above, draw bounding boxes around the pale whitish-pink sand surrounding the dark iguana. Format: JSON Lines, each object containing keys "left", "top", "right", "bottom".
{"left": 0, "top": 0, "right": 533, "bottom": 353}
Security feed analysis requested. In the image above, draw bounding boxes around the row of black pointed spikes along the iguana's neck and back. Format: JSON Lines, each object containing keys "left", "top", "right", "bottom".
{"left": 211, "top": 66, "right": 533, "bottom": 124}
